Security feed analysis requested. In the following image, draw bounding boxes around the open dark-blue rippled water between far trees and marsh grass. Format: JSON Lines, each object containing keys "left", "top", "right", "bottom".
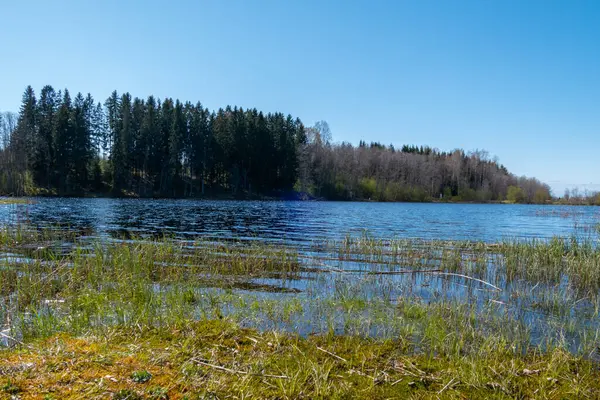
{"left": 0, "top": 198, "right": 600, "bottom": 244}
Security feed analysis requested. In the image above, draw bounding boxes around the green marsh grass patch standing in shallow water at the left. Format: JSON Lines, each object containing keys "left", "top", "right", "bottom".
{"left": 0, "top": 236, "right": 299, "bottom": 339}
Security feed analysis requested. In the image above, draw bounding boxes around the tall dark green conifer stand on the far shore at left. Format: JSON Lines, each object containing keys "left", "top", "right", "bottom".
{"left": 0, "top": 86, "right": 306, "bottom": 197}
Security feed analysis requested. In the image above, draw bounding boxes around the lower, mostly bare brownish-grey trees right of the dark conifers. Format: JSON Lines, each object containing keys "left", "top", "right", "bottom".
{"left": 301, "top": 134, "right": 551, "bottom": 203}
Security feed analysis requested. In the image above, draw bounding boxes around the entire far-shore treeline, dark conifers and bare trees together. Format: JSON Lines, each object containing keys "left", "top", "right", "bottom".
{"left": 0, "top": 86, "right": 588, "bottom": 203}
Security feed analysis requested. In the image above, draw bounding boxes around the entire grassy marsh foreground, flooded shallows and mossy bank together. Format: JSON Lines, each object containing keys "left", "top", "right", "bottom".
{"left": 0, "top": 227, "right": 600, "bottom": 399}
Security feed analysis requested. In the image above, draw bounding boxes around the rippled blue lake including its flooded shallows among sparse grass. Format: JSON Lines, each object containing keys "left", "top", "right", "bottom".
{"left": 0, "top": 198, "right": 600, "bottom": 359}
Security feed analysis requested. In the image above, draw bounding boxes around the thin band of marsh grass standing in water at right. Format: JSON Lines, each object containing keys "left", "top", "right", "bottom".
{"left": 324, "top": 235, "right": 600, "bottom": 297}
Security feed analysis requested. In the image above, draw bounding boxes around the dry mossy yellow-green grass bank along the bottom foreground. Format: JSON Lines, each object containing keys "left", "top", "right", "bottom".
{"left": 0, "top": 321, "right": 600, "bottom": 399}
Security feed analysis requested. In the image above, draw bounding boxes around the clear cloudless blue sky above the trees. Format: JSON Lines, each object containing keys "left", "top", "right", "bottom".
{"left": 0, "top": 0, "right": 600, "bottom": 195}
